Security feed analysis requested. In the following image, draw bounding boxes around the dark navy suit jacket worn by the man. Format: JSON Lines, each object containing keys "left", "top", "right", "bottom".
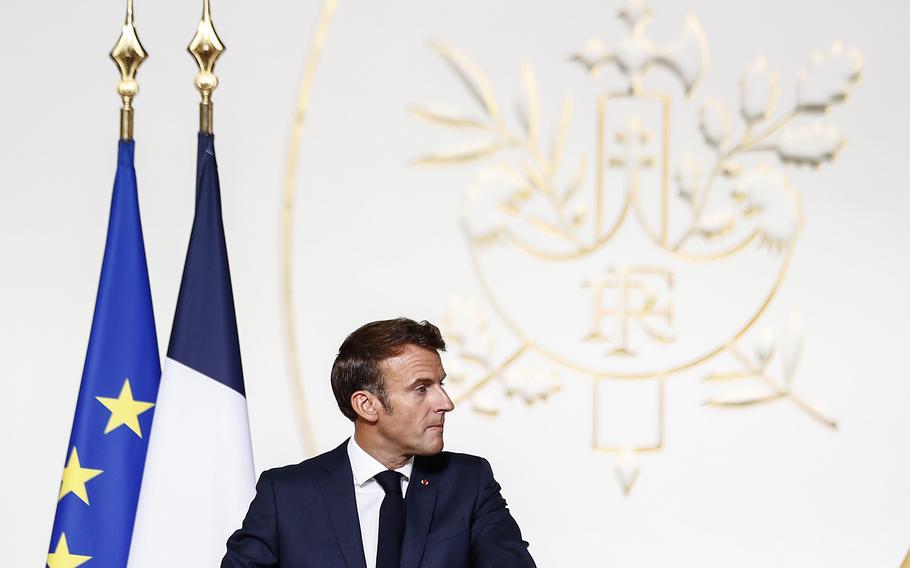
{"left": 221, "top": 442, "right": 535, "bottom": 568}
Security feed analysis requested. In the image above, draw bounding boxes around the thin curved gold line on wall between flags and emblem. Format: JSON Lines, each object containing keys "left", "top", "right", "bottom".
{"left": 281, "top": 0, "right": 336, "bottom": 455}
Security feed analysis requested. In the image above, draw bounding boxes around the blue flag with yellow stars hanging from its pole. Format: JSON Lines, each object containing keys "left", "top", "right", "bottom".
{"left": 47, "top": 140, "right": 161, "bottom": 568}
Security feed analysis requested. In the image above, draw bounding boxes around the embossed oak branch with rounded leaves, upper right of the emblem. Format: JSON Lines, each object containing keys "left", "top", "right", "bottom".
{"left": 671, "top": 42, "right": 862, "bottom": 252}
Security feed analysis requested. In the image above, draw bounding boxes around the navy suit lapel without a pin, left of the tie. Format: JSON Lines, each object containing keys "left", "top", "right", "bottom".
{"left": 320, "top": 441, "right": 366, "bottom": 568}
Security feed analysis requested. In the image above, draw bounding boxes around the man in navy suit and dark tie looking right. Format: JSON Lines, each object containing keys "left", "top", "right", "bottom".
{"left": 221, "top": 318, "right": 534, "bottom": 568}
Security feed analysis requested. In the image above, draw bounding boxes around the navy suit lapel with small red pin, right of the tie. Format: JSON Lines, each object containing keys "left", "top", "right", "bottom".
{"left": 401, "top": 456, "right": 439, "bottom": 568}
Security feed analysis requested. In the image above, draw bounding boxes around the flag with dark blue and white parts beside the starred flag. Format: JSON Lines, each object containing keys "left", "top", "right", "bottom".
{"left": 129, "top": 133, "right": 255, "bottom": 568}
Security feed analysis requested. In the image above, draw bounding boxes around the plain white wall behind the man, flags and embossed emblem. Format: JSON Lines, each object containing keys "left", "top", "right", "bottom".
{"left": 0, "top": 0, "right": 910, "bottom": 568}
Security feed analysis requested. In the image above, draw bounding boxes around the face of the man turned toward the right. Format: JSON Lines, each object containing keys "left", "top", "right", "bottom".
{"left": 376, "top": 345, "right": 455, "bottom": 456}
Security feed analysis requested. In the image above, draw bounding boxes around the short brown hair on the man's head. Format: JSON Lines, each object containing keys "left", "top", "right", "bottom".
{"left": 332, "top": 318, "right": 446, "bottom": 422}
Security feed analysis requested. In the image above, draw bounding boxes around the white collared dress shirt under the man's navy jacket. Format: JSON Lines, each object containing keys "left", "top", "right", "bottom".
{"left": 348, "top": 436, "right": 414, "bottom": 568}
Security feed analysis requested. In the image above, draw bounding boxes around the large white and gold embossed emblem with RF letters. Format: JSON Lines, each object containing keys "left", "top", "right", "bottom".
{"left": 413, "top": 1, "right": 862, "bottom": 493}
